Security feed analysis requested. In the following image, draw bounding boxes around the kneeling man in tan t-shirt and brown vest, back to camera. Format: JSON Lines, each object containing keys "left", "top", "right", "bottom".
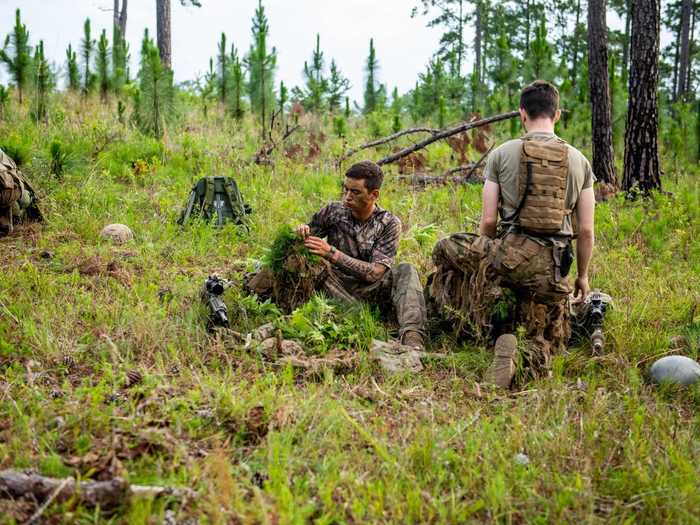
{"left": 427, "top": 81, "right": 595, "bottom": 387}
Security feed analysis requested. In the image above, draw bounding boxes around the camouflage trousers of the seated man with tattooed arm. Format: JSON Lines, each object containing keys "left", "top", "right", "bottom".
{"left": 243, "top": 263, "right": 427, "bottom": 339}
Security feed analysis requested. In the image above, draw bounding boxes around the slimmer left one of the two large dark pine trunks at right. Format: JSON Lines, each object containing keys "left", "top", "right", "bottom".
{"left": 588, "top": 0, "right": 617, "bottom": 186}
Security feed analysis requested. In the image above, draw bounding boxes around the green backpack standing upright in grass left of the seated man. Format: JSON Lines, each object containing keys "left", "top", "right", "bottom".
{"left": 177, "top": 177, "right": 251, "bottom": 228}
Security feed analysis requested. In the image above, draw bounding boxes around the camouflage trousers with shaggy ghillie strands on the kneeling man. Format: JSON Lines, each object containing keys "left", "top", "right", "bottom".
{"left": 426, "top": 233, "right": 571, "bottom": 376}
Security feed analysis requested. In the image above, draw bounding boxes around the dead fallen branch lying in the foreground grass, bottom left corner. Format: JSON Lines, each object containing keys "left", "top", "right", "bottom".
{"left": 0, "top": 470, "right": 194, "bottom": 513}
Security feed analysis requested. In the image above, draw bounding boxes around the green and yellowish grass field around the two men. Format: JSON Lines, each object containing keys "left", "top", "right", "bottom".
{"left": 0, "top": 100, "right": 700, "bottom": 524}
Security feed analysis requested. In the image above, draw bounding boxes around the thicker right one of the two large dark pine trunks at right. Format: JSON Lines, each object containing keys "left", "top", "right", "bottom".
{"left": 622, "top": 0, "right": 661, "bottom": 195}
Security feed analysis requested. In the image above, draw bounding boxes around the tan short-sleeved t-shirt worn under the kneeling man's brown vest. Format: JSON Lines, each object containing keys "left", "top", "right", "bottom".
{"left": 484, "top": 131, "right": 595, "bottom": 235}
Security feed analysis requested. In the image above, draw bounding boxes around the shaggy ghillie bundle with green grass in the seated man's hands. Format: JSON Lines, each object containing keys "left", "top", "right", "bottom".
{"left": 244, "top": 226, "right": 329, "bottom": 313}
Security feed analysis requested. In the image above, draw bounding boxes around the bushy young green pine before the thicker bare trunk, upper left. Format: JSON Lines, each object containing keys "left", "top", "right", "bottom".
{"left": 136, "top": 32, "right": 174, "bottom": 138}
